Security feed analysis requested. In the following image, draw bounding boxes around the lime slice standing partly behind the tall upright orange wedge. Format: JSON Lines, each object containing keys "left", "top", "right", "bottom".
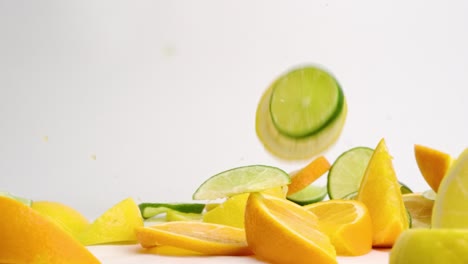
{"left": 327, "top": 147, "right": 374, "bottom": 199}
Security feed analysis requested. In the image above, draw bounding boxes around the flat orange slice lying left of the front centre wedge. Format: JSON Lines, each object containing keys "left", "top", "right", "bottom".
{"left": 135, "top": 221, "right": 252, "bottom": 255}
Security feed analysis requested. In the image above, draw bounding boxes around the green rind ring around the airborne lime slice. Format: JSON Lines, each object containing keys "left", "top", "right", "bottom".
{"left": 269, "top": 66, "right": 344, "bottom": 139}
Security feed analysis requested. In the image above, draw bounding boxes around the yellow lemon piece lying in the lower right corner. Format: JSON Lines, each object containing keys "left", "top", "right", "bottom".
{"left": 389, "top": 229, "right": 468, "bottom": 264}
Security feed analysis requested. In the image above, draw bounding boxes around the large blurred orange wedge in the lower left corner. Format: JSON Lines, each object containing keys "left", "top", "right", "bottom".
{"left": 0, "top": 196, "right": 100, "bottom": 264}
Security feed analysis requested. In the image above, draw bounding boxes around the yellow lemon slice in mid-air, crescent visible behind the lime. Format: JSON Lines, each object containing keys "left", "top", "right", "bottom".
{"left": 255, "top": 75, "right": 348, "bottom": 160}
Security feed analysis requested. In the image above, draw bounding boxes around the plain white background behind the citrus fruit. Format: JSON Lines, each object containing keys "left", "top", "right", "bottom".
{"left": 0, "top": 0, "right": 468, "bottom": 218}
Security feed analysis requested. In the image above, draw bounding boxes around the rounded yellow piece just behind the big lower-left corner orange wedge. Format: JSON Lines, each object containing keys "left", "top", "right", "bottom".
{"left": 31, "top": 201, "right": 89, "bottom": 237}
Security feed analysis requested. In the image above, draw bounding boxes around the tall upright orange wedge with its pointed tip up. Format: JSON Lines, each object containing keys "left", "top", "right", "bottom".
{"left": 357, "top": 139, "right": 409, "bottom": 247}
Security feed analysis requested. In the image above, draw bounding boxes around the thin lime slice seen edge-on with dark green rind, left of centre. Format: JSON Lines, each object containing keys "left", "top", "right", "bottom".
{"left": 138, "top": 203, "right": 205, "bottom": 219}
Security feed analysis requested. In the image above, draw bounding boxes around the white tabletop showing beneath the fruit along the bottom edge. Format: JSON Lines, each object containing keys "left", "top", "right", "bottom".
{"left": 88, "top": 245, "right": 388, "bottom": 264}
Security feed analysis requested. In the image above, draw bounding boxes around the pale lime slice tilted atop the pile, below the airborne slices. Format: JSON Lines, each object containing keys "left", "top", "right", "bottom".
{"left": 193, "top": 165, "right": 291, "bottom": 200}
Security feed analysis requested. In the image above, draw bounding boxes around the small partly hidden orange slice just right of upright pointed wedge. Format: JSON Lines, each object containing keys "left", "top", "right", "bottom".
{"left": 403, "top": 193, "right": 434, "bottom": 228}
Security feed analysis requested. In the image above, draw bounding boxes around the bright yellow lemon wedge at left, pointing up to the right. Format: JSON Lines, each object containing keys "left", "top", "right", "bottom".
{"left": 78, "top": 198, "right": 143, "bottom": 245}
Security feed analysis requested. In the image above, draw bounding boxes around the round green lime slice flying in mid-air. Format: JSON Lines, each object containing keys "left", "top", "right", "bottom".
{"left": 270, "top": 66, "right": 344, "bottom": 138}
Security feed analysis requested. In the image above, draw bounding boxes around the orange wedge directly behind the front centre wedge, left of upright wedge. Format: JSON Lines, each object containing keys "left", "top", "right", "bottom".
{"left": 304, "top": 200, "right": 372, "bottom": 256}
